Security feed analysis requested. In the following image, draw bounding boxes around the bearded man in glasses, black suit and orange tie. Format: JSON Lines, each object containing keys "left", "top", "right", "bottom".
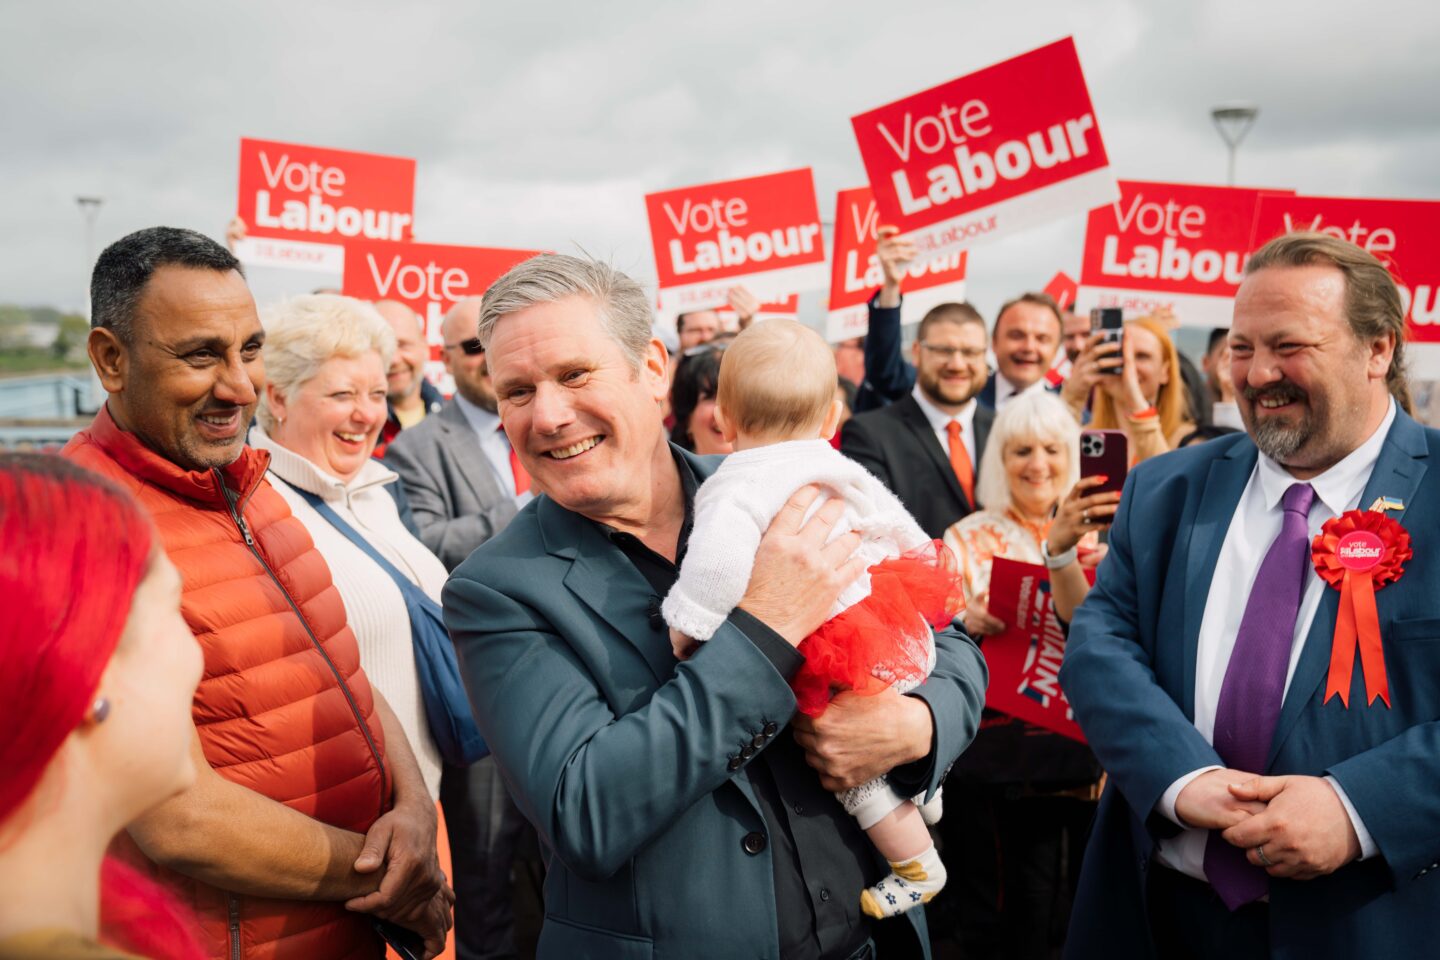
{"left": 840, "top": 304, "right": 995, "bottom": 538}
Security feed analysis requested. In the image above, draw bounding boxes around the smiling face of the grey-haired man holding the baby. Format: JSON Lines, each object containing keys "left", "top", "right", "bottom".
{"left": 485, "top": 296, "right": 670, "bottom": 520}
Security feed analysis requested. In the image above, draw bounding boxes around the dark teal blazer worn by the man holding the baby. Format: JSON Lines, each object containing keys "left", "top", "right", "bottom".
{"left": 444, "top": 453, "right": 986, "bottom": 960}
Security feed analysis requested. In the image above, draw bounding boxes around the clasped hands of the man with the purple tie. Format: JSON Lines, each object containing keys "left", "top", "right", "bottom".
{"left": 1175, "top": 769, "right": 1361, "bottom": 879}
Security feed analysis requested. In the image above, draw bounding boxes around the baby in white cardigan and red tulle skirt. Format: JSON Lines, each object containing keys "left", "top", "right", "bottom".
{"left": 661, "top": 320, "right": 963, "bottom": 918}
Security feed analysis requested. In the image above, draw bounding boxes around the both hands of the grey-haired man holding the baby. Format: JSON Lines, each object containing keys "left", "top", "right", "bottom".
{"left": 740, "top": 486, "right": 935, "bottom": 790}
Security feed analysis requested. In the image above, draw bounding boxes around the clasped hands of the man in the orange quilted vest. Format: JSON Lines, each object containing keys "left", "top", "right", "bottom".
{"left": 346, "top": 797, "right": 455, "bottom": 957}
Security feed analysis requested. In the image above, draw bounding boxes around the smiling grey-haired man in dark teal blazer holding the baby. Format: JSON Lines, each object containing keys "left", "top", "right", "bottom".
{"left": 444, "top": 255, "right": 986, "bottom": 960}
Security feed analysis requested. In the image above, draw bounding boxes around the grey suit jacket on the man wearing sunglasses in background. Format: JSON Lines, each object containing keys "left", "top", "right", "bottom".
{"left": 384, "top": 400, "right": 516, "bottom": 570}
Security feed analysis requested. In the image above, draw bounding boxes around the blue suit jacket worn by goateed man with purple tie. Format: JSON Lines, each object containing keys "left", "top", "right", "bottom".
{"left": 1060, "top": 412, "right": 1440, "bottom": 960}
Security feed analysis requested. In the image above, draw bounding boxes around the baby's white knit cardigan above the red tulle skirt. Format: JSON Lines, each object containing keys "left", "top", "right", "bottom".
{"left": 661, "top": 440, "right": 930, "bottom": 640}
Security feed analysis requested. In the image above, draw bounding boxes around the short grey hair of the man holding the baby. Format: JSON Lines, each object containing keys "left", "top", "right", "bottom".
{"left": 480, "top": 253, "right": 654, "bottom": 371}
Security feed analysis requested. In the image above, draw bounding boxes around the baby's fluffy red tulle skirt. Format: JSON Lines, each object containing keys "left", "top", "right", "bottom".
{"left": 791, "top": 540, "right": 965, "bottom": 717}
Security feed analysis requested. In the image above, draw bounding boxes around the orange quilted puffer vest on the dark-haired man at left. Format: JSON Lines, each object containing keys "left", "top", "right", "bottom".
{"left": 62, "top": 409, "right": 390, "bottom": 960}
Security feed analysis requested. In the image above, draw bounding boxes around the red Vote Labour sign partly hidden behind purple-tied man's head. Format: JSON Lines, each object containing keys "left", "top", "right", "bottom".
{"left": 1251, "top": 196, "right": 1440, "bottom": 343}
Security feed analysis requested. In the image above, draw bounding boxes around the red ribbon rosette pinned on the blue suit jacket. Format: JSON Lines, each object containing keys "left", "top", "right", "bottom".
{"left": 1310, "top": 510, "right": 1414, "bottom": 707}
